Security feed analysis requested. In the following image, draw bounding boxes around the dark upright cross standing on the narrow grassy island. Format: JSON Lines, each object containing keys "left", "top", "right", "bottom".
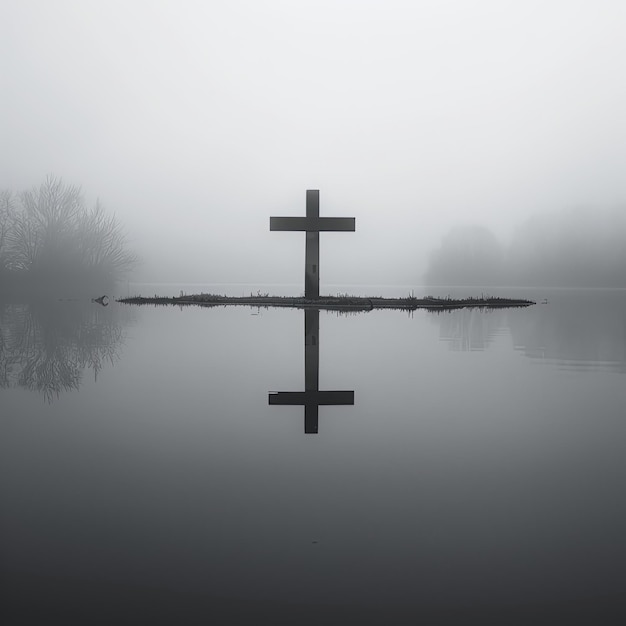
{"left": 270, "top": 189, "right": 356, "bottom": 299}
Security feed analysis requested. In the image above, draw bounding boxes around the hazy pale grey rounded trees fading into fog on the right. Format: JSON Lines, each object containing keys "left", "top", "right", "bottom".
{"left": 424, "top": 207, "right": 626, "bottom": 287}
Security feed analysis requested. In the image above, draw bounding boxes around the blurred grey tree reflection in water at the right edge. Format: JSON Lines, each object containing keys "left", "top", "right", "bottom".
{"left": 508, "top": 291, "right": 626, "bottom": 371}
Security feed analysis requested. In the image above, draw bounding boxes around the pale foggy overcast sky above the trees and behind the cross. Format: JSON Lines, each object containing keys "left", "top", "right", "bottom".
{"left": 0, "top": 0, "right": 626, "bottom": 284}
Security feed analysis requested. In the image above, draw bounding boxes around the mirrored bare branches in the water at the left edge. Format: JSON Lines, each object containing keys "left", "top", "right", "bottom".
{"left": 0, "top": 302, "right": 123, "bottom": 402}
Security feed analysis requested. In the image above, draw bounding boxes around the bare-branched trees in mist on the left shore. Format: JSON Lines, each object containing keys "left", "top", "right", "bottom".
{"left": 0, "top": 177, "right": 137, "bottom": 294}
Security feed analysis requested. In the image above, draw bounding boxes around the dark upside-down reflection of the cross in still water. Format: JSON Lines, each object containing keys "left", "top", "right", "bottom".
{"left": 269, "top": 309, "right": 354, "bottom": 434}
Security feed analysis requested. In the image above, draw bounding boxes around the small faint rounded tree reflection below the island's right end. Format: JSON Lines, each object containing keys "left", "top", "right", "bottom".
{"left": 433, "top": 308, "right": 504, "bottom": 352}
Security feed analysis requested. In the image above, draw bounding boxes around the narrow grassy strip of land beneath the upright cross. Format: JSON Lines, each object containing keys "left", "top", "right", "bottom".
{"left": 117, "top": 293, "right": 536, "bottom": 311}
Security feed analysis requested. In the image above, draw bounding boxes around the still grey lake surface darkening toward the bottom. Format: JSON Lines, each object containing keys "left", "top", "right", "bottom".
{"left": 0, "top": 288, "right": 626, "bottom": 625}
